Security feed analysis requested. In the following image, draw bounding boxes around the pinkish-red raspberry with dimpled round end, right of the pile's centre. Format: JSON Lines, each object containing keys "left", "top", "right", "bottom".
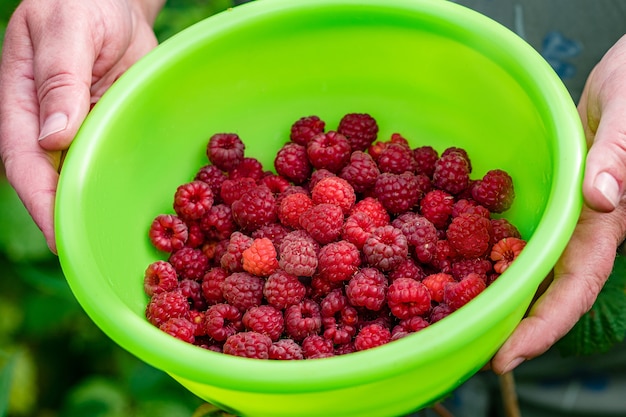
{"left": 363, "top": 225, "right": 409, "bottom": 271}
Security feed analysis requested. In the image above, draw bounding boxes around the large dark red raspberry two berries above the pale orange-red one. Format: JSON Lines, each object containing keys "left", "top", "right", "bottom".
{"left": 231, "top": 186, "right": 278, "bottom": 232}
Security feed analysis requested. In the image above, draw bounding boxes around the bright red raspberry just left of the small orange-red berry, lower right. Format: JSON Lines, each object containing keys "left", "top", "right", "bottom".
{"left": 387, "top": 278, "right": 431, "bottom": 320}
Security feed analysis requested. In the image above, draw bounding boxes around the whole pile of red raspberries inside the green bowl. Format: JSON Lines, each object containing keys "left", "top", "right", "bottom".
{"left": 143, "top": 113, "right": 525, "bottom": 360}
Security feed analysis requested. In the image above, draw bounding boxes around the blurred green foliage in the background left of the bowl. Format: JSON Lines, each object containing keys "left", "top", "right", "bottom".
{"left": 0, "top": 0, "right": 234, "bottom": 417}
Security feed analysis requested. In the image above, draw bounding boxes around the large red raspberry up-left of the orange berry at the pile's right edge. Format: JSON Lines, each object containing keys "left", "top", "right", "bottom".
{"left": 446, "top": 214, "right": 492, "bottom": 258}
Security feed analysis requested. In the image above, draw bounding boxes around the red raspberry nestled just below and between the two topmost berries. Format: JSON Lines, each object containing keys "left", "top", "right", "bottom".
{"left": 306, "top": 130, "right": 351, "bottom": 173}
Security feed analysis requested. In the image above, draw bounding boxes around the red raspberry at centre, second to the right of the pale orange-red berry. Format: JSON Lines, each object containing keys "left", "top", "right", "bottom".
{"left": 317, "top": 240, "right": 361, "bottom": 281}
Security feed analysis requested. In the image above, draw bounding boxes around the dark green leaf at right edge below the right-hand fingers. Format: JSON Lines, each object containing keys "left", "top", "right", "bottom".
{"left": 556, "top": 255, "right": 626, "bottom": 356}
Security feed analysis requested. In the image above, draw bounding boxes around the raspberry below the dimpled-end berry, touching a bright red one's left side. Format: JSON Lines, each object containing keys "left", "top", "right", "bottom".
{"left": 346, "top": 268, "right": 387, "bottom": 311}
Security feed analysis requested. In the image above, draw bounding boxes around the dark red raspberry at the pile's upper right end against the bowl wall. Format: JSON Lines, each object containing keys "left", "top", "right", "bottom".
{"left": 472, "top": 169, "right": 515, "bottom": 213}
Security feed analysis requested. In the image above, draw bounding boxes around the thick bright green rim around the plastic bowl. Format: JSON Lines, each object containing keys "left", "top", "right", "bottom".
{"left": 55, "top": 0, "right": 584, "bottom": 393}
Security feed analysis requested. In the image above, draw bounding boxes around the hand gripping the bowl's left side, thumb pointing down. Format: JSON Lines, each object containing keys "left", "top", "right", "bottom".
{"left": 0, "top": 0, "right": 165, "bottom": 253}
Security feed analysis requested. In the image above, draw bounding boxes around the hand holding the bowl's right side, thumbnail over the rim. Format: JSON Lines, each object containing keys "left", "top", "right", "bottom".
{"left": 491, "top": 36, "right": 626, "bottom": 374}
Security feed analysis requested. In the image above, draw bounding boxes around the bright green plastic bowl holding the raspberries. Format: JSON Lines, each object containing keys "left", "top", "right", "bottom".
{"left": 56, "top": 0, "right": 585, "bottom": 417}
